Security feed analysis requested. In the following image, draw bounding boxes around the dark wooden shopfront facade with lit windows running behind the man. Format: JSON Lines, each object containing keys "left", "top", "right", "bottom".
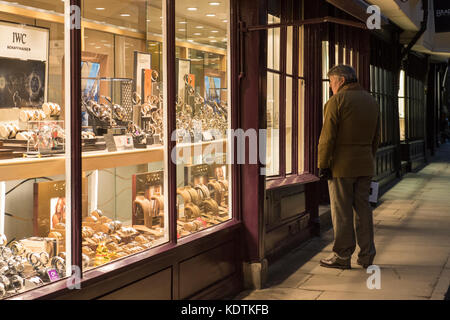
{"left": 0, "top": 0, "right": 450, "bottom": 300}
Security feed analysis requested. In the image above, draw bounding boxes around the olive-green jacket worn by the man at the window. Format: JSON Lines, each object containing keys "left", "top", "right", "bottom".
{"left": 318, "top": 83, "right": 380, "bottom": 178}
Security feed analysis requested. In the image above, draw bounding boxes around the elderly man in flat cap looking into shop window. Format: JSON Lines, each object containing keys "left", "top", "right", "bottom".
{"left": 318, "top": 65, "right": 380, "bottom": 269}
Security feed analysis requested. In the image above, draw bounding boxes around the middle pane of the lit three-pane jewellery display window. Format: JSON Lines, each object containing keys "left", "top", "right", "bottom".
{"left": 81, "top": 0, "right": 169, "bottom": 271}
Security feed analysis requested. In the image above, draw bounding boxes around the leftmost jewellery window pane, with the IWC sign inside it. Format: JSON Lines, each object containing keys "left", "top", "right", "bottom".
{"left": 0, "top": 1, "right": 71, "bottom": 299}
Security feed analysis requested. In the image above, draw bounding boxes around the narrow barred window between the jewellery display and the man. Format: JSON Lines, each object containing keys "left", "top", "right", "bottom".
{"left": 265, "top": 1, "right": 304, "bottom": 180}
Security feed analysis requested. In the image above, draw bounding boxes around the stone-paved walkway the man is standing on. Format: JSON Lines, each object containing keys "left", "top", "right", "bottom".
{"left": 235, "top": 143, "right": 450, "bottom": 300}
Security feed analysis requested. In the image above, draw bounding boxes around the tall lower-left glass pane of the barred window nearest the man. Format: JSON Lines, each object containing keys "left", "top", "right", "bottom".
{"left": 266, "top": 72, "right": 280, "bottom": 176}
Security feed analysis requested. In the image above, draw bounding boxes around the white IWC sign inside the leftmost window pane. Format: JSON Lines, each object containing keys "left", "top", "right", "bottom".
{"left": 0, "top": 22, "right": 48, "bottom": 61}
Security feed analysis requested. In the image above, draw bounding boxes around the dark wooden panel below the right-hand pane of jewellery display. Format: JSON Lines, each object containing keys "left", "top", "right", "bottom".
{"left": 179, "top": 242, "right": 236, "bottom": 299}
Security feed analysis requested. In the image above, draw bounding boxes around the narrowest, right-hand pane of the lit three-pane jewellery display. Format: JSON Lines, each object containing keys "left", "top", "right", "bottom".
{"left": 175, "top": 0, "right": 231, "bottom": 238}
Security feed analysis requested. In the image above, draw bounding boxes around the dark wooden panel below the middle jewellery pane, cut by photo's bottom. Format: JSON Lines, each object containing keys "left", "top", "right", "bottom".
{"left": 99, "top": 268, "right": 172, "bottom": 300}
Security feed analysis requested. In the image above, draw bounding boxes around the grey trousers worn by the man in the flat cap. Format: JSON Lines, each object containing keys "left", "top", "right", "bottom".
{"left": 328, "top": 177, "right": 376, "bottom": 263}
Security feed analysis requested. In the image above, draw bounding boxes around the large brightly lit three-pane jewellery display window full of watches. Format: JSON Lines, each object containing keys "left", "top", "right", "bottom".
{"left": 0, "top": 0, "right": 236, "bottom": 299}
